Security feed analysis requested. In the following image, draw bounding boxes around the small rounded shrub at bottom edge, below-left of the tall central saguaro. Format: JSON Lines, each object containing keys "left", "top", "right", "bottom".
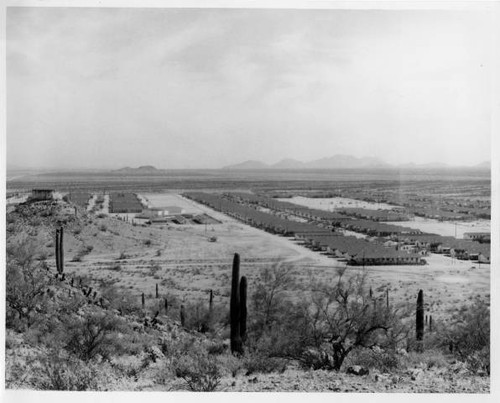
{"left": 172, "top": 354, "right": 222, "bottom": 392}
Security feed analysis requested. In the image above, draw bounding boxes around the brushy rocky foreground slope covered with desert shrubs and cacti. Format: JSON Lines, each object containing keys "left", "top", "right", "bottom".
{"left": 2, "top": 202, "right": 490, "bottom": 392}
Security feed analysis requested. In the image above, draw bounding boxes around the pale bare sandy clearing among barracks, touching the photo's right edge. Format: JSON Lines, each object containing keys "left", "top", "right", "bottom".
{"left": 388, "top": 217, "right": 491, "bottom": 238}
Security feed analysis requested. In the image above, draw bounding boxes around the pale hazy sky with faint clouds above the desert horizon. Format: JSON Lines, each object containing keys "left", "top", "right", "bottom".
{"left": 7, "top": 8, "right": 492, "bottom": 168}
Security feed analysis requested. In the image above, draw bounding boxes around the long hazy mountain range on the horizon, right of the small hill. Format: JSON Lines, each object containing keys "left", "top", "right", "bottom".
{"left": 222, "top": 155, "right": 491, "bottom": 170}
